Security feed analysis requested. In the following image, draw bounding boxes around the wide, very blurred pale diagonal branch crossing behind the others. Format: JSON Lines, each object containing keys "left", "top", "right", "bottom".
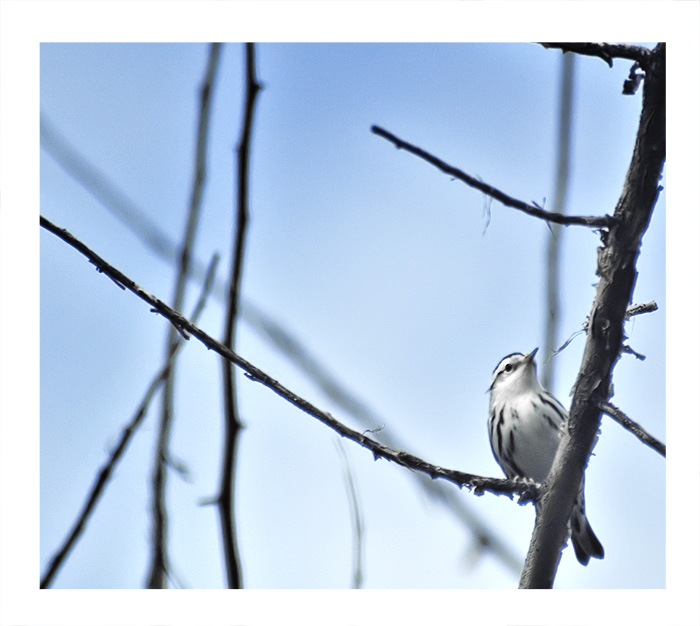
{"left": 41, "top": 106, "right": 522, "bottom": 575}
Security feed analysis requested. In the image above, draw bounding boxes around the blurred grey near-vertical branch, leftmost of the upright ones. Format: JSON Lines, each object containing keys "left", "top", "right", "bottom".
{"left": 147, "top": 43, "right": 221, "bottom": 589}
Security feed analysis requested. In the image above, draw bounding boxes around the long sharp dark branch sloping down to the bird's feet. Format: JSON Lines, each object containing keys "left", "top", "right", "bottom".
{"left": 40, "top": 215, "right": 540, "bottom": 503}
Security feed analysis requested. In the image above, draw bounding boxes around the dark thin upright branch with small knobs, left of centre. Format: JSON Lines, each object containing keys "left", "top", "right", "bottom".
{"left": 218, "top": 43, "right": 260, "bottom": 589}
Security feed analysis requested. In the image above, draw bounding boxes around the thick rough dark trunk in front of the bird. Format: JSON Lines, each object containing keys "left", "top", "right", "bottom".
{"left": 520, "top": 43, "right": 666, "bottom": 589}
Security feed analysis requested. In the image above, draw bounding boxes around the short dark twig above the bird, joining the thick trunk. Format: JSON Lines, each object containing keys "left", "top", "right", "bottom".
{"left": 372, "top": 126, "right": 614, "bottom": 228}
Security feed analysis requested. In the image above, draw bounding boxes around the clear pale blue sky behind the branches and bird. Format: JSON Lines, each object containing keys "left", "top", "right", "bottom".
{"left": 41, "top": 39, "right": 666, "bottom": 588}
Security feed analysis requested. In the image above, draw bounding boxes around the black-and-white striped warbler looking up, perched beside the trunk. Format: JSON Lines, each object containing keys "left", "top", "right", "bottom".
{"left": 488, "top": 348, "right": 604, "bottom": 565}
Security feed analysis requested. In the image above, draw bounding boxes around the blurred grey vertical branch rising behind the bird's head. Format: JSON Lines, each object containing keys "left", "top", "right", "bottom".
{"left": 542, "top": 52, "right": 576, "bottom": 389}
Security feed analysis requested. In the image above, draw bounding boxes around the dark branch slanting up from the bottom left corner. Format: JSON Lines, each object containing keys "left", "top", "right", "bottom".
{"left": 41, "top": 255, "right": 219, "bottom": 589}
